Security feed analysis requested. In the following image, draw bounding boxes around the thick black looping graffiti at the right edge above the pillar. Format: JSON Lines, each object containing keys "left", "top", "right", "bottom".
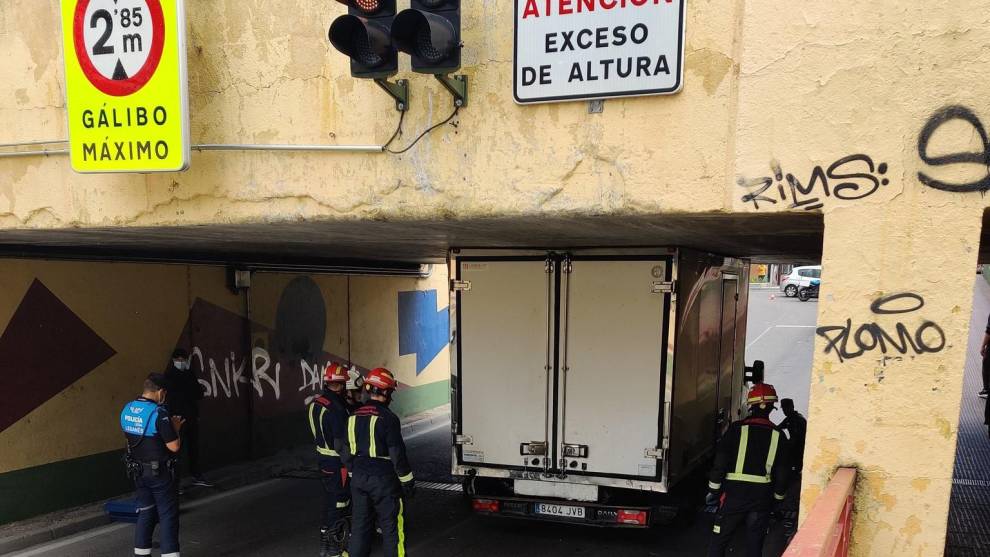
{"left": 918, "top": 105, "right": 990, "bottom": 193}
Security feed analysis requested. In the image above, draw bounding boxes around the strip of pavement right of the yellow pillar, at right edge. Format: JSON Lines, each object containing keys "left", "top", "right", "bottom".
{"left": 945, "top": 276, "right": 990, "bottom": 557}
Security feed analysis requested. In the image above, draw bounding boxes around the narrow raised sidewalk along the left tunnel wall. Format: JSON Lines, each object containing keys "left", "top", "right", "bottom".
{"left": 0, "top": 404, "right": 450, "bottom": 555}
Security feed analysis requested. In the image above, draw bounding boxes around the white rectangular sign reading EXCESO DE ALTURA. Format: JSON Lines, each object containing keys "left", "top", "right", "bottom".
{"left": 513, "top": 0, "right": 686, "bottom": 104}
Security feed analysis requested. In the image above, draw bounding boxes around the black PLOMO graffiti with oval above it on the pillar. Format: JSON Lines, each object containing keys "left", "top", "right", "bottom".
{"left": 817, "top": 292, "right": 946, "bottom": 362}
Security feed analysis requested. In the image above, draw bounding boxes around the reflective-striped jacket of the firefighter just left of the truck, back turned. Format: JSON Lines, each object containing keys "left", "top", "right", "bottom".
{"left": 341, "top": 400, "right": 413, "bottom": 483}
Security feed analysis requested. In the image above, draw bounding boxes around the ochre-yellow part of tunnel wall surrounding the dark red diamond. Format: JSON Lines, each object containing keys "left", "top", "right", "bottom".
{"left": 0, "top": 260, "right": 236, "bottom": 473}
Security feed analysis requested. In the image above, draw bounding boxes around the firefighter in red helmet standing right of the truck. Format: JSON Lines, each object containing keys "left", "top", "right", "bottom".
{"left": 706, "top": 383, "right": 791, "bottom": 557}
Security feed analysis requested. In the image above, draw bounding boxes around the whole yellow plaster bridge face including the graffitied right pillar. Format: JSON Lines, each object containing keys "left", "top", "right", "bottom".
{"left": 0, "top": 0, "right": 990, "bottom": 555}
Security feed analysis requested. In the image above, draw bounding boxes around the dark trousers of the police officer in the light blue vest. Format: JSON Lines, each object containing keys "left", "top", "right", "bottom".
{"left": 134, "top": 472, "right": 179, "bottom": 557}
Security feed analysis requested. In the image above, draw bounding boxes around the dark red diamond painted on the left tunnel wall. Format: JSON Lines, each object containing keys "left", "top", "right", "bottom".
{"left": 0, "top": 279, "right": 116, "bottom": 431}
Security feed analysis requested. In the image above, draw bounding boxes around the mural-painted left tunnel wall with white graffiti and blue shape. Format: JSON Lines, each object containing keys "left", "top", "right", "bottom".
{"left": 0, "top": 260, "right": 449, "bottom": 523}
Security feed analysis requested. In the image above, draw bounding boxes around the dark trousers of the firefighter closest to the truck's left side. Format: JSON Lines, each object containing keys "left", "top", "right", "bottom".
{"left": 348, "top": 472, "right": 406, "bottom": 557}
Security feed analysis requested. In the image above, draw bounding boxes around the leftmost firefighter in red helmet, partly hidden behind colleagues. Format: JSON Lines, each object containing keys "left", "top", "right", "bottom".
{"left": 309, "top": 362, "right": 351, "bottom": 557}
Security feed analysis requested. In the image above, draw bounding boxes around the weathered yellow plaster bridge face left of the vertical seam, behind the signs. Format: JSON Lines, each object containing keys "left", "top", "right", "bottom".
{"left": 0, "top": 0, "right": 735, "bottom": 227}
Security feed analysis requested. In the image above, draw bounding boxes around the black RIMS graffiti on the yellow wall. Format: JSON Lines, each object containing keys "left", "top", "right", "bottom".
{"left": 736, "top": 153, "right": 890, "bottom": 211}
